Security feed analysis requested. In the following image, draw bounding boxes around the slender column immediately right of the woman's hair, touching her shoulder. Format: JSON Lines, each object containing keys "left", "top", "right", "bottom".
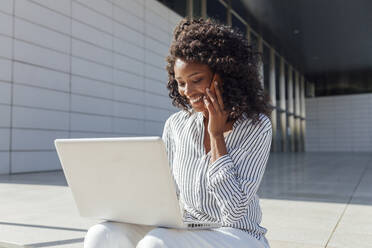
{"left": 269, "top": 47, "right": 278, "bottom": 152}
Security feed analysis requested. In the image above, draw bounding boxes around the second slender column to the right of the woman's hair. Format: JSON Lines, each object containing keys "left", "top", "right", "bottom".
{"left": 279, "top": 57, "right": 287, "bottom": 152}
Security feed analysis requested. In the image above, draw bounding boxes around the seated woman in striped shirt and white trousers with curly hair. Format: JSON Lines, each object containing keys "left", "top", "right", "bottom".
{"left": 84, "top": 19, "right": 272, "bottom": 248}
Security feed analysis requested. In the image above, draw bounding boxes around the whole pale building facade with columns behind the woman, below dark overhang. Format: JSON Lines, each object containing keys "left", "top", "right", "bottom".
{"left": 0, "top": 0, "right": 372, "bottom": 174}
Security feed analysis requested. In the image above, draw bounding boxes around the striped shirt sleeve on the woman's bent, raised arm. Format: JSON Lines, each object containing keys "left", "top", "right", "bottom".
{"left": 207, "top": 126, "right": 272, "bottom": 224}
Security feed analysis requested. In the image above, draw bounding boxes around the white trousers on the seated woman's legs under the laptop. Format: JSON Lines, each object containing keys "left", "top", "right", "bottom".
{"left": 84, "top": 222, "right": 269, "bottom": 248}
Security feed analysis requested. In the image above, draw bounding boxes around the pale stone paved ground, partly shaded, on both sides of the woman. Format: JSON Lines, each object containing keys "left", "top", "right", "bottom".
{"left": 0, "top": 153, "right": 372, "bottom": 248}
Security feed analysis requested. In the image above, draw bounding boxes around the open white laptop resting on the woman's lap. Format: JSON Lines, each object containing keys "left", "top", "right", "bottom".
{"left": 55, "top": 137, "right": 220, "bottom": 229}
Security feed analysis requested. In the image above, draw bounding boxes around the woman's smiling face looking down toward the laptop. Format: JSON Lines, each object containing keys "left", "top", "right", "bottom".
{"left": 174, "top": 58, "right": 218, "bottom": 112}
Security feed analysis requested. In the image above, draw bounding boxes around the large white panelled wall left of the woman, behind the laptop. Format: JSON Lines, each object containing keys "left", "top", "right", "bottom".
{"left": 0, "top": 0, "right": 180, "bottom": 174}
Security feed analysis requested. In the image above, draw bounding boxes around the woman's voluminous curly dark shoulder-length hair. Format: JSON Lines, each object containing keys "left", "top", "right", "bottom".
{"left": 166, "top": 18, "right": 272, "bottom": 123}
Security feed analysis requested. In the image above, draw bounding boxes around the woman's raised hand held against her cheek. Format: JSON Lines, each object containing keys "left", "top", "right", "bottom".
{"left": 204, "top": 81, "right": 228, "bottom": 137}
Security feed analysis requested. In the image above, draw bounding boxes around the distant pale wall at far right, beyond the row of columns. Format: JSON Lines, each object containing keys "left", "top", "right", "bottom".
{"left": 306, "top": 94, "right": 372, "bottom": 152}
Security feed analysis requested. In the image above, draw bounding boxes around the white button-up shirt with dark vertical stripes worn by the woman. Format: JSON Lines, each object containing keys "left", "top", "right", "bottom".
{"left": 163, "top": 110, "right": 272, "bottom": 238}
